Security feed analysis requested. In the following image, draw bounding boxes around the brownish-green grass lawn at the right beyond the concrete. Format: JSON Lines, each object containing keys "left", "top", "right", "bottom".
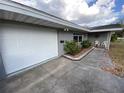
{"left": 109, "top": 40, "right": 124, "bottom": 76}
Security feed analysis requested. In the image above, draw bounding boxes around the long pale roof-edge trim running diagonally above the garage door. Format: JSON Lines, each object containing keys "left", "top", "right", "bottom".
{"left": 0, "top": 0, "right": 90, "bottom": 32}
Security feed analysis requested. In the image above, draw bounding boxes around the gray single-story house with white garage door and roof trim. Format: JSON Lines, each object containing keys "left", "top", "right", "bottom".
{"left": 0, "top": 0, "right": 122, "bottom": 78}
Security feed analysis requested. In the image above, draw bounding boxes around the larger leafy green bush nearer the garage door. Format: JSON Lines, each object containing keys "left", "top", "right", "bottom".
{"left": 64, "top": 41, "right": 80, "bottom": 55}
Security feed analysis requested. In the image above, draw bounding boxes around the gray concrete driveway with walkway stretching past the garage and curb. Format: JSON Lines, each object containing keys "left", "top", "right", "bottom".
{"left": 0, "top": 49, "right": 124, "bottom": 93}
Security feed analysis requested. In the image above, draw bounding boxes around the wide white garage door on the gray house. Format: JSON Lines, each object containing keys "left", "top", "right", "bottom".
{"left": 1, "top": 24, "right": 58, "bottom": 74}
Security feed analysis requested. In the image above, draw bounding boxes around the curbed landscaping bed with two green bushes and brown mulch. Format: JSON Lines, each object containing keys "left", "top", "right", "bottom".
{"left": 64, "top": 40, "right": 93, "bottom": 60}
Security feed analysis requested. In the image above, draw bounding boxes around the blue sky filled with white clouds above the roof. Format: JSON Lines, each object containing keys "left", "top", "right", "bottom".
{"left": 12, "top": 0, "right": 124, "bottom": 27}
